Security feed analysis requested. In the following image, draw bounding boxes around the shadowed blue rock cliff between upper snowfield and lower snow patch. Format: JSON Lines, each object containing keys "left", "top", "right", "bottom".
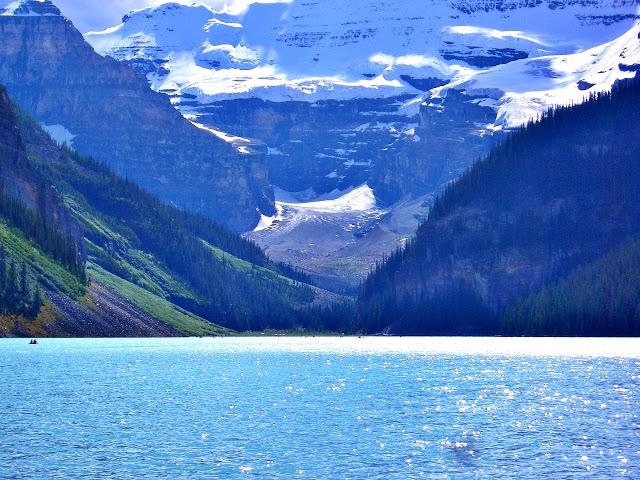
{"left": 198, "top": 96, "right": 419, "bottom": 197}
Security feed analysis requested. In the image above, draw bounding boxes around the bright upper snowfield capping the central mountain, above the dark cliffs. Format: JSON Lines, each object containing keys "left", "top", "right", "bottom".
{"left": 86, "top": 0, "right": 640, "bottom": 102}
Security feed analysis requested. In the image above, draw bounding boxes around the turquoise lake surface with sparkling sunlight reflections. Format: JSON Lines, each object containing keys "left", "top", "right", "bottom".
{"left": 0, "top": 338, "right": 640, "bottom": 480}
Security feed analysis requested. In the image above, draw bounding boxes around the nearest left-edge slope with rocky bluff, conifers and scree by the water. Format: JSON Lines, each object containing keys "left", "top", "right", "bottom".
{"left": 0, "top": 82, "right": 186, "bottom": 336}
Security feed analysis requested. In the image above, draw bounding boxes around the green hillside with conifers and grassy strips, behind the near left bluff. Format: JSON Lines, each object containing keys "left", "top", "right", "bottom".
{"left": 0, "top": 89, "right": 336, "bottom": 335}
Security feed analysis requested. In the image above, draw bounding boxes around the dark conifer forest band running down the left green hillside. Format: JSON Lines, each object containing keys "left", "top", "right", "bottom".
{"left": 11, "top": 109, "right": 330, "bottom": 330}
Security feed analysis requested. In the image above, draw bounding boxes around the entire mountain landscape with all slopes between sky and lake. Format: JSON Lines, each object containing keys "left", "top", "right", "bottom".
{"left": 0, "top": 0, "right": 640, "bottom": 336}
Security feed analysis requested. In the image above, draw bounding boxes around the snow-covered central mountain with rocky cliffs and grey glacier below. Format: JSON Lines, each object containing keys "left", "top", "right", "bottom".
{"left": 86, "top": 0, "right": 640, "bottom": 287}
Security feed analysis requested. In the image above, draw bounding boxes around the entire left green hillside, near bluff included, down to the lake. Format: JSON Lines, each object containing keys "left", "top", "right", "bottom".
{"left": 0, "top": 83, "right": 336, "bottom": 336}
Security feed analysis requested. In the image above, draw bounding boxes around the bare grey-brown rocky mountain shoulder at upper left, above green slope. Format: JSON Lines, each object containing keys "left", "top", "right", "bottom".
{"left": 0, "top": 0, "right": 273, "bottom": 230}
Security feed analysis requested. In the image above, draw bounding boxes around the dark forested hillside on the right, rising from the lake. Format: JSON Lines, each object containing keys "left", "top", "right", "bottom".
{"left": 359, "top": 80, "right": 640, "bottom": 335}
